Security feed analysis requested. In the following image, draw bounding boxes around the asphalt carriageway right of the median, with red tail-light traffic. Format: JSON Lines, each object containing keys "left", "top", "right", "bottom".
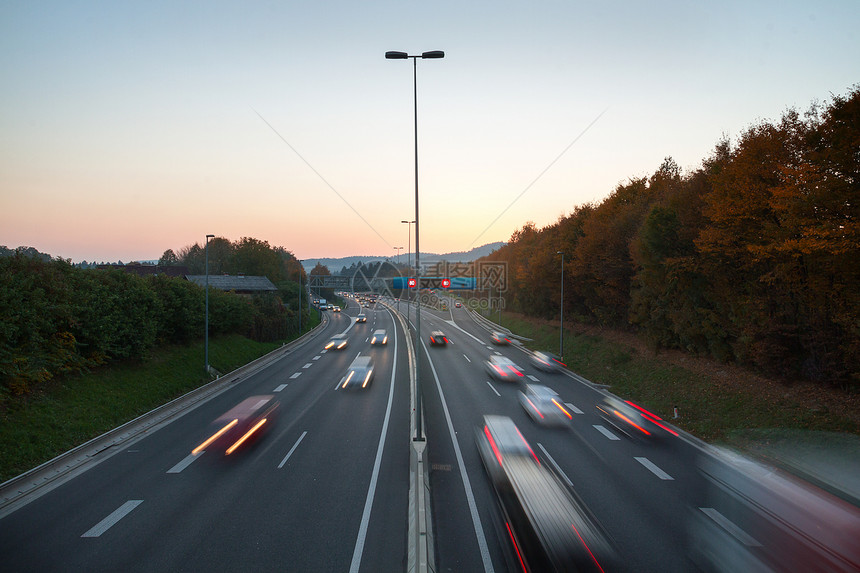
{"left": 410, "top": 298, "right": 702, "bottom": 571}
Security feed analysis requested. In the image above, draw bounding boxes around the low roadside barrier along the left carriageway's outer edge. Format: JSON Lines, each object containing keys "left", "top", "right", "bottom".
{"left": 0, "top": 316, "right": 328, "bottom": 517}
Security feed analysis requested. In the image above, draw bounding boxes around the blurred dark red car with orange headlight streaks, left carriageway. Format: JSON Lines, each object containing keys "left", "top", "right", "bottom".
{"left": 191, "top": 394, "right": 280, "bottom": 456}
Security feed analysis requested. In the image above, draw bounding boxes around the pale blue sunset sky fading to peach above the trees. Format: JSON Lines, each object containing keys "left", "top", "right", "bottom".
{"left": 0, "top": 0, "right": 860, "bottom": 262}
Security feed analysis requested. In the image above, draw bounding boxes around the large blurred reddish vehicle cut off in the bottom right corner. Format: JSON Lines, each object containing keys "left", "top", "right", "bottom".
{"left": 687, "top": 448, "right": 860, "bottom": 573}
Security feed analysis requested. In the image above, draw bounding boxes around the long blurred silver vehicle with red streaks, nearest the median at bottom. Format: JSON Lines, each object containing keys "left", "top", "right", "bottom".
{"left": 476, "top": 416, "right": 618, "bottom": 572}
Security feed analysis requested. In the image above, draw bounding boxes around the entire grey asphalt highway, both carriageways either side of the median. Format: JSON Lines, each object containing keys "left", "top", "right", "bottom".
{"left": 0, "top": 292, "right": 857, "bottom": 572}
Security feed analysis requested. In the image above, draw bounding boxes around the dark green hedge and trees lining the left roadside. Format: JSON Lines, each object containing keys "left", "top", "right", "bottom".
{"left": 0, "top": 238, "right": 310, "bottom": 405}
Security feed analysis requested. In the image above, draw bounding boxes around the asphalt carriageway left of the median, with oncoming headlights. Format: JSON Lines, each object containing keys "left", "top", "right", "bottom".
{"left": 0, "top": 303, "right": 409, "bottom": 571}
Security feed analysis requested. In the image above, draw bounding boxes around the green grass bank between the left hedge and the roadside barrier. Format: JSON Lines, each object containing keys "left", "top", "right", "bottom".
{"left": 0, "top": 335, "right": 281, "bottom": 483}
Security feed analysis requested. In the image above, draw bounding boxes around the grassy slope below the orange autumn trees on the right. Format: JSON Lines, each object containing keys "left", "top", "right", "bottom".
{"left": 488, "top": 312, "right": 860, "bottom": 445}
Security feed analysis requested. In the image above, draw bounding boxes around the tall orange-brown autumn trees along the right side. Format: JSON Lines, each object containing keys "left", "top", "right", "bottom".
{"left": 484, "top": 86, "right": 860, "bottom": 389}
